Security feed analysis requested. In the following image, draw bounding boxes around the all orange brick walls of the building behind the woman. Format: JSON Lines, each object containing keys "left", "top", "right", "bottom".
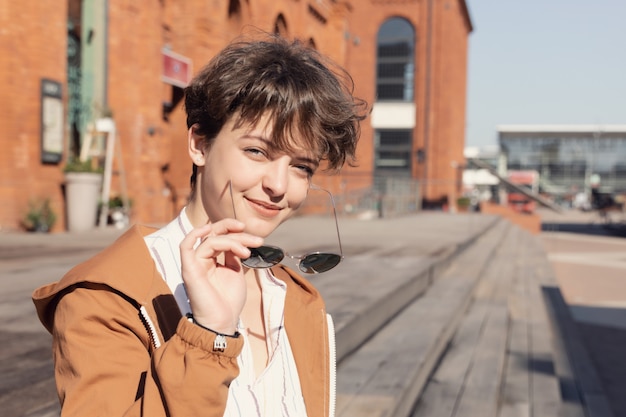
{"left": 0, "top": 0, "right": 468, "bottom": 231}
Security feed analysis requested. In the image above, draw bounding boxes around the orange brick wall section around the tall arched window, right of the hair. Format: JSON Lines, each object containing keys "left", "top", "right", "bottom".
{"left": 347, "top": 0, "right": 471, "bottom": 200}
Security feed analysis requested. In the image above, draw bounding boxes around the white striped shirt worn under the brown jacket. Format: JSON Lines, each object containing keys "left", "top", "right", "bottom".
{"left": 144, "top": 208, "right": 306, "bottom": 417}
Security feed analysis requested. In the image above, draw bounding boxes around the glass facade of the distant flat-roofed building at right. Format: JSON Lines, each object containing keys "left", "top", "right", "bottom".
{"left": 498, "top": 129, "right": 626, "bottom": 194}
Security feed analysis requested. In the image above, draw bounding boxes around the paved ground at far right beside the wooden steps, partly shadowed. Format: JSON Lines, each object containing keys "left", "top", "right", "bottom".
{"left": 541, "top": 208, "right": 626, "bottom": 416}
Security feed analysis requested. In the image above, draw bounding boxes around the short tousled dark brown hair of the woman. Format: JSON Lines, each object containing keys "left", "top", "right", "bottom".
{"left": 185, "top": 35, "right": 367, "bottom": 187}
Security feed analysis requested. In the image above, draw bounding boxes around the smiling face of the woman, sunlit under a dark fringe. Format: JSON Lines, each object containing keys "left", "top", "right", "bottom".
{"left": 192, "top": 117, "right": 319, "bottom": 237}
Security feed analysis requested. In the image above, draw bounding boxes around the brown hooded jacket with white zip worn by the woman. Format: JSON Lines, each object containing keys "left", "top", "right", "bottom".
{"left": 33, "top": 226, "right": 334, "bottom": 417}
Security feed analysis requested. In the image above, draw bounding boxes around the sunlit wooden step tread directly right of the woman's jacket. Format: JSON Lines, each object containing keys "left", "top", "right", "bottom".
{"left": 337, "top": 221, "right": 509, "bottom": 417}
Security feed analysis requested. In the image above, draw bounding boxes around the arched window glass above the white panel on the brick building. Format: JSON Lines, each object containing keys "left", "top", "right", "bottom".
{"left": 376, "top": 17, "right": 415, "bottom": 101}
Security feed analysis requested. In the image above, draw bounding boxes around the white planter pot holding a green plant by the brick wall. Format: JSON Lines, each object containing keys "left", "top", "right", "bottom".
{"left": 65, "top": 172, "right": 102, "bottom": 232}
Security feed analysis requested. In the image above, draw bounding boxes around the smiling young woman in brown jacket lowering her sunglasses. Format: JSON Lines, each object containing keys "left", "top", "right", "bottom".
{"left": 33, "top": 38, "right": 364, "bottom": 417}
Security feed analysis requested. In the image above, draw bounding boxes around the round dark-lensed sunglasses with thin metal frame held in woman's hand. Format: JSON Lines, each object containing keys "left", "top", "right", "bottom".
{"left": 229, "top": 182, "right": 343, "bottom": 274}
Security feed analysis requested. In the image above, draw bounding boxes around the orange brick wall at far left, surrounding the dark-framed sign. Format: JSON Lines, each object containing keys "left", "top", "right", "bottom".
{"left": 0, "top": 0, "right": 67, "bottom": 231}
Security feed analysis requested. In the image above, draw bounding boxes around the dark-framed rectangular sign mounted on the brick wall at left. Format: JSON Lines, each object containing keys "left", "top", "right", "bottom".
{"left": 41, "top": 78, "right": 64, "bottom": 164}
